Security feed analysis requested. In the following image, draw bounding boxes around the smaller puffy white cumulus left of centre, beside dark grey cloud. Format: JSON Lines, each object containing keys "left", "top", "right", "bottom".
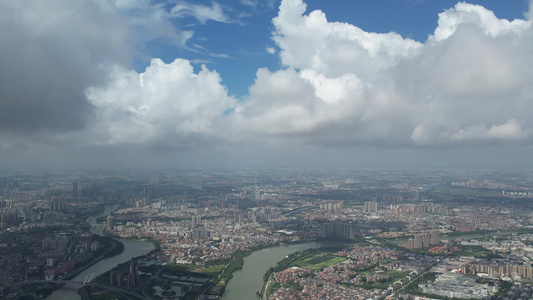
{"left": 87, "top": 59, "right": 235, "bottom": 147}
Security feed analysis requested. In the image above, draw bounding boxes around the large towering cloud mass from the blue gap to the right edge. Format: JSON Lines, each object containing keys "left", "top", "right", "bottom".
{"left": 234, "top": 0, "right": 533, "bottom": 147}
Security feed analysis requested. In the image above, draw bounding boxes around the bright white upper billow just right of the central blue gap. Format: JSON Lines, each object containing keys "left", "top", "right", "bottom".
{"left": 272, "top": 0, "right": 422, "bottom": 78}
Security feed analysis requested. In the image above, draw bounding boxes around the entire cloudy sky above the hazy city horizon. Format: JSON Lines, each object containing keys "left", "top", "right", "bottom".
{"left": 0, "top": 0, "right": 533, "bottom": 168}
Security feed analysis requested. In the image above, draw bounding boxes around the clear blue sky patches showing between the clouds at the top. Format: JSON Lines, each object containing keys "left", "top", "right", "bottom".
{"left": 138, "top": 0, "right": 529, "bottom": 98}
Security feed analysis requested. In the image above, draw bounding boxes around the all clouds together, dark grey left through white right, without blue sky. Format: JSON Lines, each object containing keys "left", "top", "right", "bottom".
{"left": 0, "top": 0, "right": 533, "bottom": 165}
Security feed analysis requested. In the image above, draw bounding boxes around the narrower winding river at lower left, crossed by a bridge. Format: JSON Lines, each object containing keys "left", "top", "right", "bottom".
{"left": 46, "top": 206, "right": 155, "bottom": 300}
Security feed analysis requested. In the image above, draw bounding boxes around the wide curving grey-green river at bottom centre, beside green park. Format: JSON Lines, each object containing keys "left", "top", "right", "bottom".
{"left": 222, "top": 242, "right": 344, "bottom": 300}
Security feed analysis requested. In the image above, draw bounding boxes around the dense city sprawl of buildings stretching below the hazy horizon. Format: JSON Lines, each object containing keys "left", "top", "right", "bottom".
{"left": 0, "top": 169, "right": 533, "bottom": 300}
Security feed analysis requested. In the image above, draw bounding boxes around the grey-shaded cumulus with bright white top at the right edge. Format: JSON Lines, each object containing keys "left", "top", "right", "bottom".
{"left": 404, "top": 3, "right": 533, "bottom": 145}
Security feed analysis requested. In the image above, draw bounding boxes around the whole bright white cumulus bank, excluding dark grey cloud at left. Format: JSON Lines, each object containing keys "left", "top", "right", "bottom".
{"left": 61, "top": 0, "right": 533, "bottom": 152}
